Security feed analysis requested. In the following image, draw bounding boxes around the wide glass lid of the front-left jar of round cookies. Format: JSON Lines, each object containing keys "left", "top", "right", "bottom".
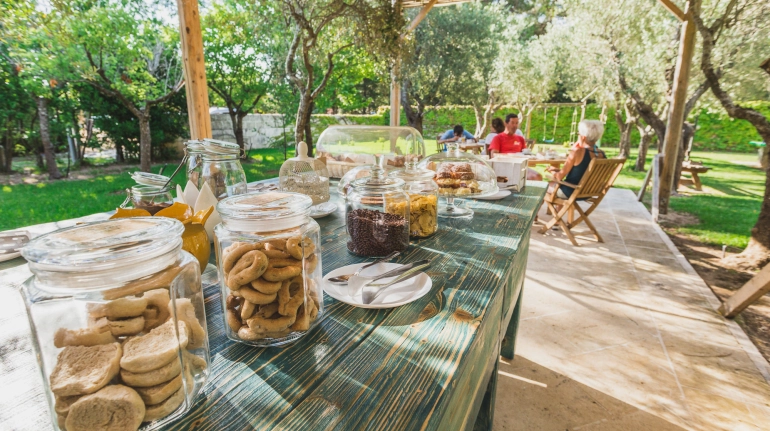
{"left": 21, "top": 217, "right": 184, "bottom": 289}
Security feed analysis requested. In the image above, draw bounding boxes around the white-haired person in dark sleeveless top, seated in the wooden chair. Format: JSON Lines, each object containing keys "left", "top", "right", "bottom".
{"left": 548, "top": 120, "right": 607, "bottom": 199}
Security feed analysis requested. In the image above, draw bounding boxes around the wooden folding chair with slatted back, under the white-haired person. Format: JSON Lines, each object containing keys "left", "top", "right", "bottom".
{"left": 539, "top": 159, "right": 626, "bottom": 246}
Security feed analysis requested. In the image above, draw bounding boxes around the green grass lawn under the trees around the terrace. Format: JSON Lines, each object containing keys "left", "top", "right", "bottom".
{"left": 0, "top": 146, "right": 764, "bottom": 248}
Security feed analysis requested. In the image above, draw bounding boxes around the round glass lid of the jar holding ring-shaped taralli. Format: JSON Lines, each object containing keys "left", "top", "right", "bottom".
{"left": 217, "top": 192, "right": 313, "bottom": 232}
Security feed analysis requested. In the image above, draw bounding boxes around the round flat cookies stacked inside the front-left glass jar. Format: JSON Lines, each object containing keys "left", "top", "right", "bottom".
{"left": 49, "top": 289, "right": 207, "bottom": 431}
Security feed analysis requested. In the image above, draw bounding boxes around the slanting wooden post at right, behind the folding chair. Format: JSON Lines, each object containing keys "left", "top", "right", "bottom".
{"left": 658, "top": 0, "right": 700, "bottom": 214}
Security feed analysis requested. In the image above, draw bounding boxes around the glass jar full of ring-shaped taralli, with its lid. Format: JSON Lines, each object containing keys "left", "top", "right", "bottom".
{"left": 214, "top": 192, "right": 323, "bottom": 347}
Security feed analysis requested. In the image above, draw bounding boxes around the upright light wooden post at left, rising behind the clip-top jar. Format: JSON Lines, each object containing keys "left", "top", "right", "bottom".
{"left": 176, "top": 0, "right": 212, "bottom": 139}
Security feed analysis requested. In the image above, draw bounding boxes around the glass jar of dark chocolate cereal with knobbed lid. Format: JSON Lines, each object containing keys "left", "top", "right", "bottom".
{"left": 345, "top": 155, "right": 409, "bottom": 257}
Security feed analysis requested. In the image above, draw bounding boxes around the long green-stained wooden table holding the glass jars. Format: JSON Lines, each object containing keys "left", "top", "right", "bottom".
{"left": 0, "top": 182, "right": 546, "bottom": 431}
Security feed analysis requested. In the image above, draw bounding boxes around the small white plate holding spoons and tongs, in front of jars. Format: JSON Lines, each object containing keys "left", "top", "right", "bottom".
{"left": 323, "top": 262, "right": 433, "bottom": 308}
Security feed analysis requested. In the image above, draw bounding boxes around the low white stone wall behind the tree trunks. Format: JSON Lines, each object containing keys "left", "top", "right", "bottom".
{"left": 211, "top": 114, "right": 293, "bottom": 149}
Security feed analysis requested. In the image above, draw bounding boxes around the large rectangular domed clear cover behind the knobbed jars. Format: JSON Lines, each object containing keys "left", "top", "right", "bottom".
{"left": 316, "top": 125, "right": 425, "bottom": 158}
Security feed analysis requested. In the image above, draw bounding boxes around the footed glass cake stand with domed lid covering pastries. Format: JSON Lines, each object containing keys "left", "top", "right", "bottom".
{"left": 418, "top": 142, "right": 499, "bottom": 217}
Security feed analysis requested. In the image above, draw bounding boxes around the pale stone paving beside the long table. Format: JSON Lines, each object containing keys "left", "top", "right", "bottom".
{"left": 494, "top": 189, "right": 770, "bottom": 431}
